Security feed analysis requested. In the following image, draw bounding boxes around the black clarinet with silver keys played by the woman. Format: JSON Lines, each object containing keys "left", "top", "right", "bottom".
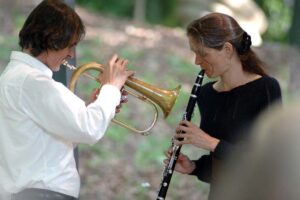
{"left": 156, "top": 70, "right": 204, "bottom": 200}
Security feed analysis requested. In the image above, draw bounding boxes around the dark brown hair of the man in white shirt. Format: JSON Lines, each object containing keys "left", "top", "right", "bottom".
{"left": 19, "top": 0, "right": 85, "bottom": 56}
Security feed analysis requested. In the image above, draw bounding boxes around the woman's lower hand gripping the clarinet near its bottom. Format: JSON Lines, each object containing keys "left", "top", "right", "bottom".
{"left": 164, "top": 148, "right": 196, "bottom": 174}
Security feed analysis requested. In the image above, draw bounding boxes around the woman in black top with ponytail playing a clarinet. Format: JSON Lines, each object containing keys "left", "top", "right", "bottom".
{"left": 164, "top": 13, "right": 281, "bottom": 199}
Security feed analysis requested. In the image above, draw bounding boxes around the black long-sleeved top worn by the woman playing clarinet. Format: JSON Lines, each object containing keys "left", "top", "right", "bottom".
{"left": 191, "top": 76, "right": 281, "bottom": 186}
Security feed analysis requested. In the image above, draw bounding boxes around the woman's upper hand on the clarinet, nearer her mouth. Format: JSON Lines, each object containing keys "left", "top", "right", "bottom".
{"left": 174, "top": 120, "right": 220, "bottom": 152}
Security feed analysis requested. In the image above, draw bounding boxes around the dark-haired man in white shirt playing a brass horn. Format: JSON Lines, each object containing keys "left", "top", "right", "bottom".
{"left": 0, "top": 0, "right": 133, "bottom": 200}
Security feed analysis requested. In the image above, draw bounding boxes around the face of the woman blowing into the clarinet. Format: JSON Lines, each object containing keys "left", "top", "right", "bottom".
{"left": 189, "top": 37, "right": 230, "bottom": 78}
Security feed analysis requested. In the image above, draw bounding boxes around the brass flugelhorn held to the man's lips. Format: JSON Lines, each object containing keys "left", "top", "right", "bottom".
{"left": 63, "top": 61, "right": 181, "bottom": 135}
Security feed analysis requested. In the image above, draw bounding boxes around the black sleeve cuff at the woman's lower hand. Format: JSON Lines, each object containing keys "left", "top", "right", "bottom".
{"left": 190, "top": 155, "right": 212, "bottom": 183}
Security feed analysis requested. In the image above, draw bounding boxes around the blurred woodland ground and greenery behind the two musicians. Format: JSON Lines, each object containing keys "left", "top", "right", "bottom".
{"left": 0, "top": 0, "right": 300, "bottom": 200}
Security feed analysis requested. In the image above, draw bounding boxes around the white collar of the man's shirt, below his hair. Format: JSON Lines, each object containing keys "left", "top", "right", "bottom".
{"left": 10, "top": 51, "right": 53, "bottom": 77}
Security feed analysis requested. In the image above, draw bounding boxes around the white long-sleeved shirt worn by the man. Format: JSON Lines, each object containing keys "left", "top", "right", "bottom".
{"left": 0, "top": 51, "right": 121, "bottom": 197}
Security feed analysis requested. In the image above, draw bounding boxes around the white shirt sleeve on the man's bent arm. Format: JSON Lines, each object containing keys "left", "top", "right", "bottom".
{"left": 20, "top": 74, "right": 121, "bottom": 144}
